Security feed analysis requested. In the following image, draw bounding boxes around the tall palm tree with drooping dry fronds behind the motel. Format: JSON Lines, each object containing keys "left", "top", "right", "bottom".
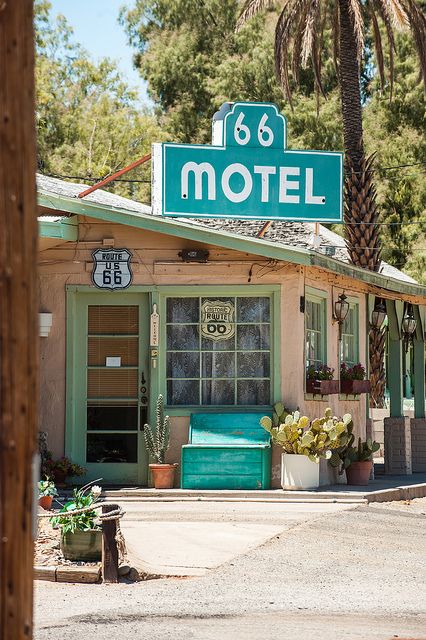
{"left": 237, "top": 0, "right": 426, "bottom": 406}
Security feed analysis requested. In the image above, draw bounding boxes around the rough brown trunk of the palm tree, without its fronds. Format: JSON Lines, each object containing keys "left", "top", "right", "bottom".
{"left": 339, "top": 0, "right": 385, "bottom": 407}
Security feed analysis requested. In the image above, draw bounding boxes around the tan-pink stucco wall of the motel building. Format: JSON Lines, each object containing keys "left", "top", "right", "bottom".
{"left": 39, "top": 219, "right": 366, "bottom": 486}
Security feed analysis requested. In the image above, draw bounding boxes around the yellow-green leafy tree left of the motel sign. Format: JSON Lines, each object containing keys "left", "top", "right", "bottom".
{"left": 35, "top": 0, "right": 163, "bottom": 201}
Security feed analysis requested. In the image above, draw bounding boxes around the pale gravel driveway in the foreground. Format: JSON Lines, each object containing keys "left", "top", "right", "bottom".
{"left": 35, "top": 500, "right": 426, "bottom": 640}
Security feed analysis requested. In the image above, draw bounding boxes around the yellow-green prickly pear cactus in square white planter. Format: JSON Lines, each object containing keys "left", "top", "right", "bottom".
{"left": 260, "top": 409, "right": 352, "bottom": 490}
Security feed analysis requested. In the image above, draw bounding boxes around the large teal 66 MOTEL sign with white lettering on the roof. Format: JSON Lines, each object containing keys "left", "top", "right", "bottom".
{"left": 153, "top": 102, "right": 343, "bottom": 222}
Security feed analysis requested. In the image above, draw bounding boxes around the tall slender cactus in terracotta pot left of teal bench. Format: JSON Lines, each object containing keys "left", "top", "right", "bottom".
{"left": 144, "top": 395, "right": 177, "bottom": 489}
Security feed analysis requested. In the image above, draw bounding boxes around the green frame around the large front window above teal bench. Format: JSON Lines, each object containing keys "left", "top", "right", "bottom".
{"left": 158, "top": 285, "right": 281, "bottom": 416}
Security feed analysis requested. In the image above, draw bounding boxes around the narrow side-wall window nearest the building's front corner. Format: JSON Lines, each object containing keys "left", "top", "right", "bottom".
{"left": 305, "top": 294, "right": 327, "bottom": 367}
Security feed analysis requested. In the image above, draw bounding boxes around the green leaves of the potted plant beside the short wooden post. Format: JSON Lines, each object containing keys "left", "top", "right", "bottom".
{"left": 50, "top": 485, "right": 102, "bottom": 533}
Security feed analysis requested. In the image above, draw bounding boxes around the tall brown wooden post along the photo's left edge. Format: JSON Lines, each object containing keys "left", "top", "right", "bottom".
{"left": 0, "top": 0, "right": 39, "bottom": 640}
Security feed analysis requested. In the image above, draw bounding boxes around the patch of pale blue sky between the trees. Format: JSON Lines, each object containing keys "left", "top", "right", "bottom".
{"left": 50, "top": 0, "right": 149, "bottom": 102}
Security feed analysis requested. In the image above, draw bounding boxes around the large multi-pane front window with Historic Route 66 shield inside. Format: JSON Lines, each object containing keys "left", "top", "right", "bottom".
{"left": 166, "top": 296, "right": 271, "bottom": 406}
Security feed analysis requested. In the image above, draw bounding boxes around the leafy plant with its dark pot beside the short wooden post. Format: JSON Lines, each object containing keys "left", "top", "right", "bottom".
{"left": 50, "top": 485, "right": 102, "bottom": 562}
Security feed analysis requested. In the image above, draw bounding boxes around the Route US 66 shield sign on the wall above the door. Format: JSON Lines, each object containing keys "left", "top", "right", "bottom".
{"left": 92, "top": 249, "right": 133, "bottom": 291}
